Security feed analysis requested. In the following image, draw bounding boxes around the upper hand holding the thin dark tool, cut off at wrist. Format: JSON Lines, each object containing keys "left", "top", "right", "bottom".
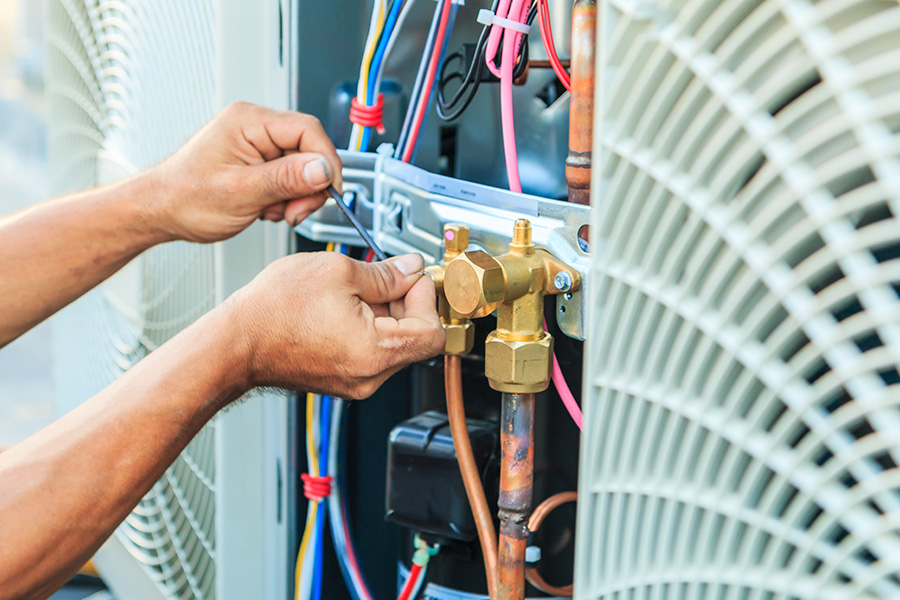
{"left": 149, "top": 102, "right": 341, "bottom": 242}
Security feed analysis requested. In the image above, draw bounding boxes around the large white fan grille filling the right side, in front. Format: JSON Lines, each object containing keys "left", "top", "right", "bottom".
{"left": 576, "top": 0, "right": 900, "bottom": 600}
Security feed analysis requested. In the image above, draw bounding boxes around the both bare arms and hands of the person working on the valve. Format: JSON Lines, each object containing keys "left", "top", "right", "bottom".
{"left": 0, "top": 103, "right": 444, "bottom": 600}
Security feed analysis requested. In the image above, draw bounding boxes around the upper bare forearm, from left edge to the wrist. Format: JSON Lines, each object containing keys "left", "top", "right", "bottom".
{"left": 0, "top": 174, "right": 170, "bottom": 347}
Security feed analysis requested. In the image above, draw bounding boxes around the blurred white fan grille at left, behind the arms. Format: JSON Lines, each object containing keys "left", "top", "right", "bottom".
{"left": 47, "top": 0, "right": 215, "bottom": 598}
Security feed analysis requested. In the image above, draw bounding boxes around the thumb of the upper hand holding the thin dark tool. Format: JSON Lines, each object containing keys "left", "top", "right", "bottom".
{"left": 253, "top": 152, "right": 335, "bottom": 204}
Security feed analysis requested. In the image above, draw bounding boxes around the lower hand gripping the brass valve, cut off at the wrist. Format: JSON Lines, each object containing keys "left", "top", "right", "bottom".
{"left": 227, "top": 252, "right": 444, "bottom": 398}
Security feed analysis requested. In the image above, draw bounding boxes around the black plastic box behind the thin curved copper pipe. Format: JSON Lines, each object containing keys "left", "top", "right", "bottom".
{"left": 385, "top": 411, "right": 500, "bottom": 542}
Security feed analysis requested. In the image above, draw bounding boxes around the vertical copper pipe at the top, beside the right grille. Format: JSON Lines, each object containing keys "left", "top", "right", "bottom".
{"left": 566, "top": 0, "right": 597, "bottom": 204}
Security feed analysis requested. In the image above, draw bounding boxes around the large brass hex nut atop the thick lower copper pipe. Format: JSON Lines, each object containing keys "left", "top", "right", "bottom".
{"left": 484, "top": 332, "right": 553, "bottom": 394}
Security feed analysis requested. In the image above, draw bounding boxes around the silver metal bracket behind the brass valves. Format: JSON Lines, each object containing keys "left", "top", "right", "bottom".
{"left": 295, "top": 152, "right": 591, "bottom": 340}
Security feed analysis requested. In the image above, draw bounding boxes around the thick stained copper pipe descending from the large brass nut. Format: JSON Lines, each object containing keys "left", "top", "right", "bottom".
{"left": 497, "top": 393, "right": 534, "bottom": 600}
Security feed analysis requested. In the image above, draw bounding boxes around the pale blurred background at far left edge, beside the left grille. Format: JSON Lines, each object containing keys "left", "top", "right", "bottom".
{"left": 0, "top": 0, "right": 53, "bottom": 447}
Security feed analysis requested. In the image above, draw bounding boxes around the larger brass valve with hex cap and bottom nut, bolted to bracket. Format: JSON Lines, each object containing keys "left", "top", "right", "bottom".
{"left": 441, "top": 219, "right": 580, "bottom": 394}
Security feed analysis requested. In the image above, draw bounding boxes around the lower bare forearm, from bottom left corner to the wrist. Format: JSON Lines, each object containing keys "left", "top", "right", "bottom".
{"left": 0, "top": 307, "right": 247, "bottom": 600}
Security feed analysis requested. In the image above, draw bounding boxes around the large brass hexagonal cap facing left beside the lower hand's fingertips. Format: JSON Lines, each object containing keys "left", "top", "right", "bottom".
{"left": 444, "top": 250, "right": 506, "bottom": 318}
